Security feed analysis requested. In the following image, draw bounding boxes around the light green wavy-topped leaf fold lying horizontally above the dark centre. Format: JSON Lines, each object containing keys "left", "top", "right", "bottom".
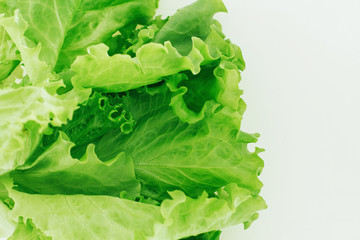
{"left": 71, "top": 38, "right": 216, "bottom": 92}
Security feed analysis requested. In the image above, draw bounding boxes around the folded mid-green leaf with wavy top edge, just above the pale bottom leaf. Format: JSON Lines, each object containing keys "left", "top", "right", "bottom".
{"left": 10, "top": 132, "right": 140, "bottom": 197}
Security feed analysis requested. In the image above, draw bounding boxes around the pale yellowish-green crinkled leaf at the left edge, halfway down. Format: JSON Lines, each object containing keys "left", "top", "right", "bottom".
{"left": 0, "top": 82, "right": 89, "bottom": 174}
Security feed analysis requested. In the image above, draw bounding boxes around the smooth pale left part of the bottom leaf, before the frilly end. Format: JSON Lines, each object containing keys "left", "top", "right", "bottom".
{"left": 11, "top": 188, "right": 163, "bottom": 240}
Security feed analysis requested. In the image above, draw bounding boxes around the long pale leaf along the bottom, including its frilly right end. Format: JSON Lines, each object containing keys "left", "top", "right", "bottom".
{"left": 10, "top": 184, "right": 266, "bottom": 240}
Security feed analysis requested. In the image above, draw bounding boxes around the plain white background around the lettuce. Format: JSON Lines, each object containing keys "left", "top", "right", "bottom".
{"left": 159, "top": 0, "right": 360, "bottom": 240}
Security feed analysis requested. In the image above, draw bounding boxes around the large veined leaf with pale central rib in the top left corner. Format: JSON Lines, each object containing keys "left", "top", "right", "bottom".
{"left": 0, "top": 0, "right": 156, "bottom": 82}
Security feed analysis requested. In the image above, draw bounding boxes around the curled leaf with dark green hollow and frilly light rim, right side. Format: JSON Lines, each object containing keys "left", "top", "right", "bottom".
{"left": 165, "top": 60, "right": 246, "bottom": 124}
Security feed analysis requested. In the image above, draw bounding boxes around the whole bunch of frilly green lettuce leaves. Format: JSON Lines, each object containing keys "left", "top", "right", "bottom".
{"left": 0, "top": 0, "right": 266, "bottom": 240}
